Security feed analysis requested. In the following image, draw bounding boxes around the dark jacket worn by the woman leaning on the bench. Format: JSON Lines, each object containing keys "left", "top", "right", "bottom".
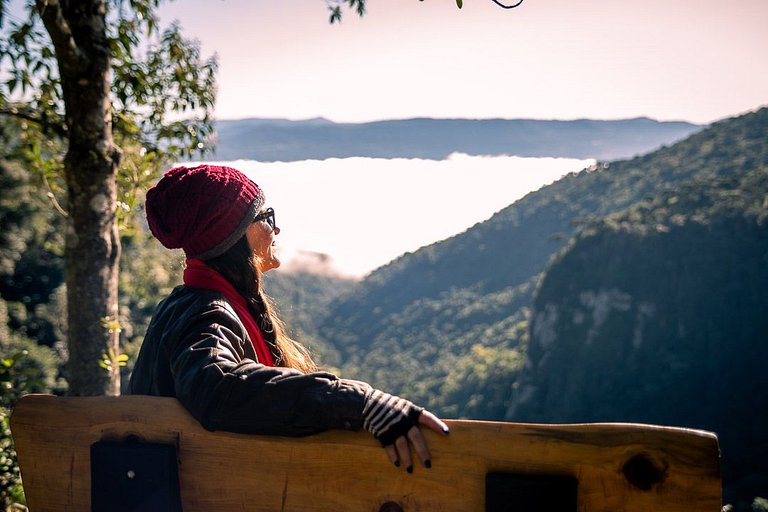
{"left": 129, "top": 286, "right": 373, "bottom": 436}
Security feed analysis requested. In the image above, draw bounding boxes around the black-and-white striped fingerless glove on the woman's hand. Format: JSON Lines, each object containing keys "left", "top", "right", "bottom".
{"left": 363, "top": 389, "right": 424, "bottom": 446}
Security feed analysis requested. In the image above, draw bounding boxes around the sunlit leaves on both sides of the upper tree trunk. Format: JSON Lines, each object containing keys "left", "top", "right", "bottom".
{"left": 0, "top": 0, "right": 218, "bottom": 229}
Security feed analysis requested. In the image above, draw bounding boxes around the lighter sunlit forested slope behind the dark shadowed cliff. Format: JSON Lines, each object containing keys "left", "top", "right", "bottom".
{"left": 320, "top": 109, "right": 768, "bottom": 412}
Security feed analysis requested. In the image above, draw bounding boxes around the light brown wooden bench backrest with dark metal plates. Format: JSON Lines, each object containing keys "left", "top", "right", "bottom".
{"left": 11, "top": 395, "right": 721, "bottom": 512}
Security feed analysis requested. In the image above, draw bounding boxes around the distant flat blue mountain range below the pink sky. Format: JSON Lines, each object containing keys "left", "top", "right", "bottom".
{"left": 210, "top": 118, "right": 702, "bottom": 162}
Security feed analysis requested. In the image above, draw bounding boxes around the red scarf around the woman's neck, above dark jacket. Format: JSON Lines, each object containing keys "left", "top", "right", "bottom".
{"left": 184, "top": 259, "right": 275, "bottom": 366}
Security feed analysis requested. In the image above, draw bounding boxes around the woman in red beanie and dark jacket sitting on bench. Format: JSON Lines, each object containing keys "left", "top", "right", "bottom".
{"left": 129, "top": 165, "right": 448, "bottom": 473}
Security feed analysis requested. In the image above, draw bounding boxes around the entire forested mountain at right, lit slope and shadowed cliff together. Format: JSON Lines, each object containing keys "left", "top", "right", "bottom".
{"left": 317, "top": 108, "right": 768, "bottom": 510}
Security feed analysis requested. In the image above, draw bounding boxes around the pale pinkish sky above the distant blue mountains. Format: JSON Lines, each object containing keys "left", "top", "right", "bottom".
{"left": 160, "top": 0, "right": 768, "bottom": 124}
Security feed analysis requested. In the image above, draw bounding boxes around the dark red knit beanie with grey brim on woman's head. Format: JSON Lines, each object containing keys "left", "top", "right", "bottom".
{"left": 146, "top": 165, "right": 264, "bottom": 260}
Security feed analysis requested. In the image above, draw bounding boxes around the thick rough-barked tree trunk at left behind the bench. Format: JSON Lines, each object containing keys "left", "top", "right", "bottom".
{"left": 38, "top": 0, "right": 120, "bottom": 395}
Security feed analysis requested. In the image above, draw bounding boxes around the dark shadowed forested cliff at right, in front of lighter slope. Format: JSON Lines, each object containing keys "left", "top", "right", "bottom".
{"left": 506, "top": 170, "right": 768, "bottom": 508}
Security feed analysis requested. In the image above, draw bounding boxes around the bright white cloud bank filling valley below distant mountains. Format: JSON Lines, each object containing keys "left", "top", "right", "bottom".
{"left": 190, "top": 153, "right": 594, "bottom": 276}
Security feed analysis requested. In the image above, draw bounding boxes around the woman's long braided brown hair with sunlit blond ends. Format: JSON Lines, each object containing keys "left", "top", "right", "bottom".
{"left": 205, "top": 236, "right": 317, "bottom": 373}
